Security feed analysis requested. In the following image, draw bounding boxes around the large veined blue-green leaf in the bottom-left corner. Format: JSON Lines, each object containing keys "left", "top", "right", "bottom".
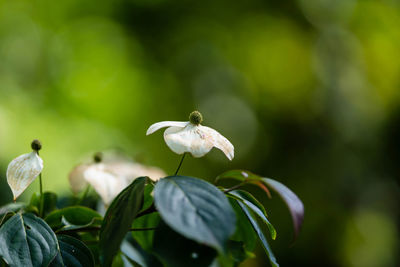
{"left": 0, "top": 213, "right": 59, "bottom": 267}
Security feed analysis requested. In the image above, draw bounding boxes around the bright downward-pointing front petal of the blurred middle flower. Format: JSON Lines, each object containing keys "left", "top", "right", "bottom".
{"left": 83, "top": 163, "right": 129, "bottom": 206}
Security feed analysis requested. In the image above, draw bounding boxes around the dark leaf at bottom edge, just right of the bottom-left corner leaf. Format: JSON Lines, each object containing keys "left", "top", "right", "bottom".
{"left": 50, "top": 235, "right": 94, "bottom": 267}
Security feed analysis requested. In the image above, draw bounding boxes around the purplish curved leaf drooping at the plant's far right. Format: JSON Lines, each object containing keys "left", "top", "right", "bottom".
{"left": 262, "top": 178, "right": 304, "bottom": 242}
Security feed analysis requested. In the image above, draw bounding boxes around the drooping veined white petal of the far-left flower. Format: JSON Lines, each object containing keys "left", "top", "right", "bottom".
{"left": 7, "top": 152, "right": 43, "bottom": 200}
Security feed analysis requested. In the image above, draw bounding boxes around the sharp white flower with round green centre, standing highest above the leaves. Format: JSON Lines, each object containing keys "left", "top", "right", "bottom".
{"left": 146, "top": 111, "right": 234, "bottom": 160}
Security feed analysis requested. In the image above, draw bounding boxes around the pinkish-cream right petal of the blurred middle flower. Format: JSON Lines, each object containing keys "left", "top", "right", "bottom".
{"left": 107, "top": 161, "right": 167, "bottom": 183}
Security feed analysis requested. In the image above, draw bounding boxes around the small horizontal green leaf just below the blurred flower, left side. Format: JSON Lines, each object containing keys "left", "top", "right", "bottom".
{"left": 45, "top": 206, "right": 101, "bottom": 231}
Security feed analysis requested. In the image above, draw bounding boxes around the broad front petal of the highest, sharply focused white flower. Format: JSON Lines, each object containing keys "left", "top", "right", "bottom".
{"left": 164, "top": 123, "right": 213, "bottom": 158}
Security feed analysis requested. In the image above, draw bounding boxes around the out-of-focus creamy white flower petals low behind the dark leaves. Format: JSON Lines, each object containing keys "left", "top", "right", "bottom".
{"left": 69, "top": 157, "right": 167, "bottom": 206}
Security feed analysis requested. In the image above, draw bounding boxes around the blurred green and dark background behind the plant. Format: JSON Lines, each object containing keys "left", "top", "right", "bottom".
{"left": 0, "top": 0, "right": 400, "bottom": 267}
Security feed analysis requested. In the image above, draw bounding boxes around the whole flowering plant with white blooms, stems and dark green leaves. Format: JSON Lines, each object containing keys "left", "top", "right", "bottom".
{"left": 0, "top": 111, "right": 304, "bottom": 267}
